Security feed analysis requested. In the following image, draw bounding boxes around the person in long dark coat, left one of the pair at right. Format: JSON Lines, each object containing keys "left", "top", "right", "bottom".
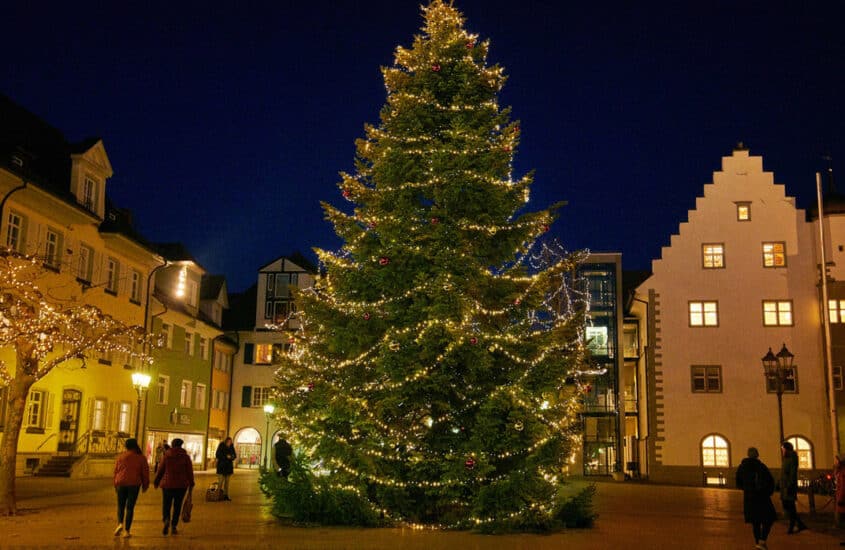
{"left": 736, "top": 447, "right": 777, "bottom": 550}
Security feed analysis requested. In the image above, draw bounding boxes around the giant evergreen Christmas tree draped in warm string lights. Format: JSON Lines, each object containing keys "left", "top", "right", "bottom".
{"left": 277, "top": 0, "right": 589, "bottom": 528}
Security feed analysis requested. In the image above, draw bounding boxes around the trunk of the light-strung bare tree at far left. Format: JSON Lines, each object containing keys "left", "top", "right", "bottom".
{"left": 0, "top": 349, "right": 37, "bottom": 516}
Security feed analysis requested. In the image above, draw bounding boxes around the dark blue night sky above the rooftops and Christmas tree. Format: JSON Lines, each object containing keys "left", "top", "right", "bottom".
{"left": 0, "top": 0, "right": 845, "bottom": 291}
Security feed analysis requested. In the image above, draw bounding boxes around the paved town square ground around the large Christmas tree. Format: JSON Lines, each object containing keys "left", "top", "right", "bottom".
{"left": 0, "top": 471, "right": 845, "bottom": 550}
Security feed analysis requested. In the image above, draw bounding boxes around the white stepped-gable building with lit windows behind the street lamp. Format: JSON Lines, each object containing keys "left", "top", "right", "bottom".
{"left": 637, "top": 146, "right": 835, "bottom": 485}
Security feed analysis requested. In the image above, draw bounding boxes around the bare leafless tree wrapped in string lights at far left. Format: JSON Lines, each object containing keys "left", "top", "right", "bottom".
{"left": 0, "top": 250, "right": 149, "bottom": 516}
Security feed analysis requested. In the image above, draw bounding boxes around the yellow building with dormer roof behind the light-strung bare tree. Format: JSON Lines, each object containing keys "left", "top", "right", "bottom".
{"left": 0, "top": 96, "right": 163, "bottom": 476}
